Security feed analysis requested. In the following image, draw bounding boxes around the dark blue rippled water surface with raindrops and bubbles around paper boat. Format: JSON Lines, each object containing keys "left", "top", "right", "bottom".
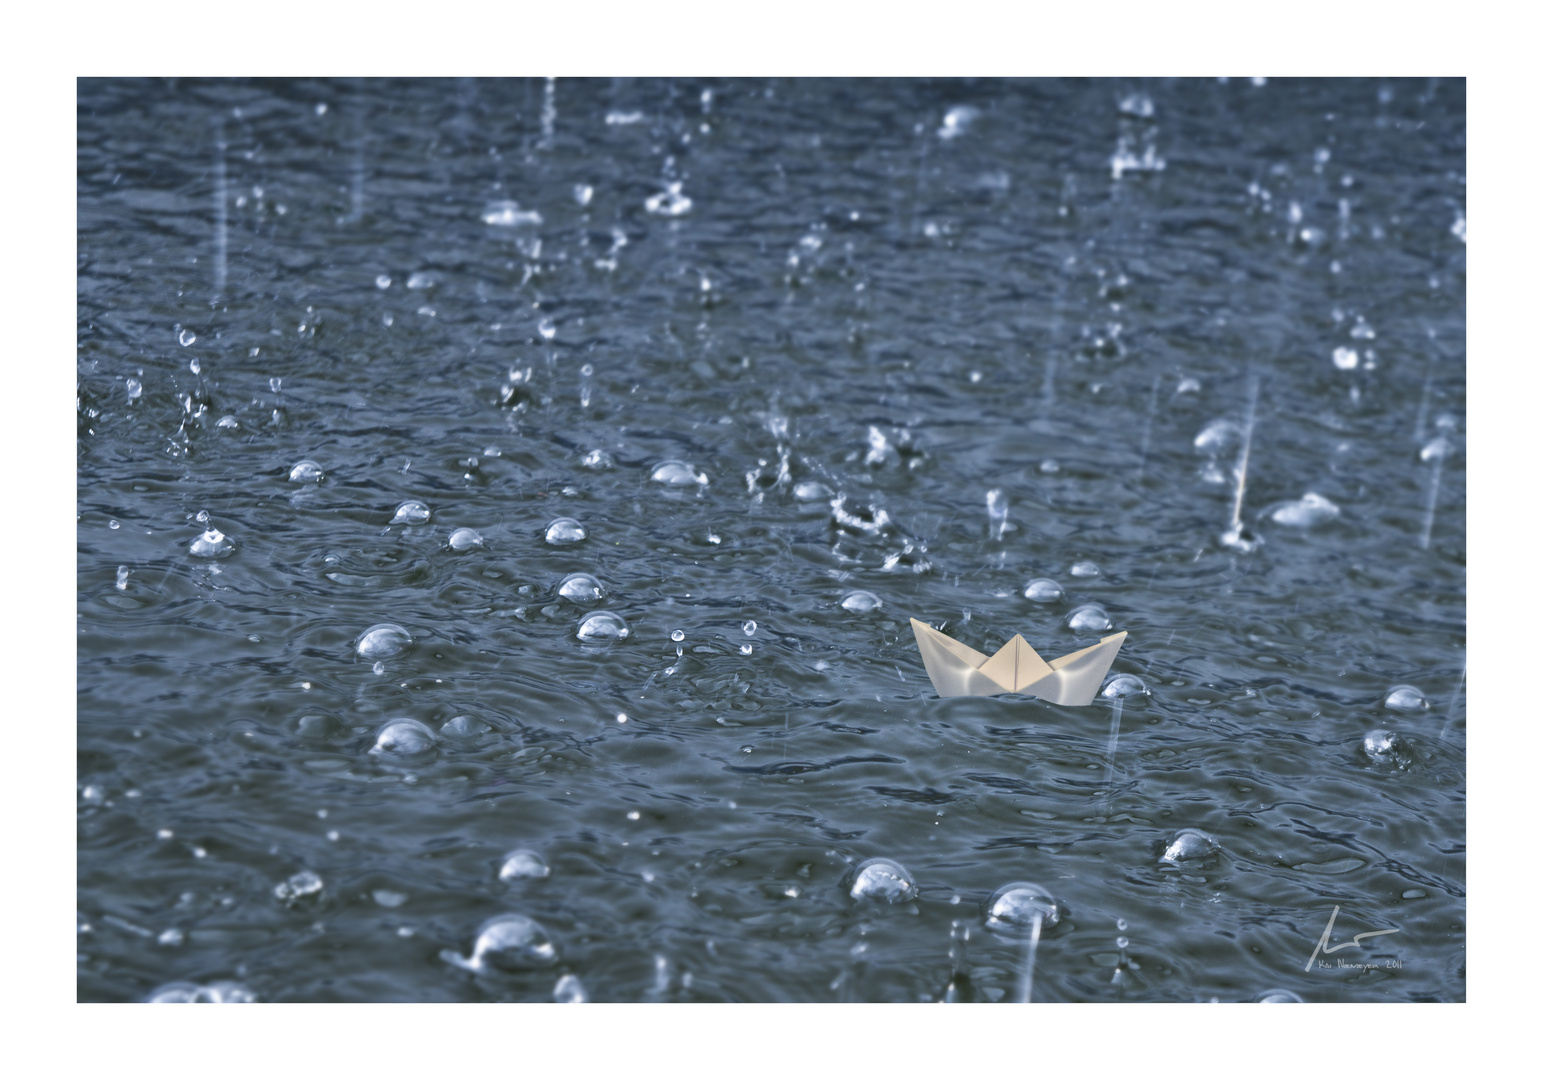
{"left": 77, "top": 80, "right": 1466, "bottom": 1001}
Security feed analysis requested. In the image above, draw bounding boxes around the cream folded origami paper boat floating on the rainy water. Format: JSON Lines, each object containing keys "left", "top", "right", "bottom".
{"left": 910, "top": 619, "right": 1125, "bottom": 705}
